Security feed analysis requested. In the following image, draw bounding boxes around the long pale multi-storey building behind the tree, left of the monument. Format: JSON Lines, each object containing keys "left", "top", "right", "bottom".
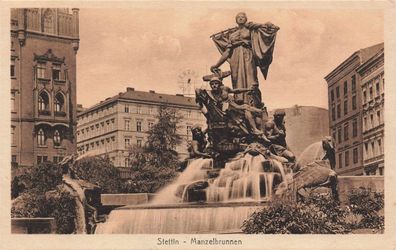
{"left": 77, "top": 88, "right": 206, "bottom": 170}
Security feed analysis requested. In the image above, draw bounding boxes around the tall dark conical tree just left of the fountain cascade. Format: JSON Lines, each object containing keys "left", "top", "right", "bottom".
{"left": 124, "top": 105, "right": 182, "bottom": 193}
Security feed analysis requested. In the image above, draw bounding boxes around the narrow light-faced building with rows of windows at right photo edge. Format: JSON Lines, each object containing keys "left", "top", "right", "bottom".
{"left": 357, "top": 49, "right": 385, "bottom": 175}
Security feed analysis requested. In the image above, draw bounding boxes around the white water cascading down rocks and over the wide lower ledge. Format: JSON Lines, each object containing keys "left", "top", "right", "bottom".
{"left": 95, "top": 154, "right": 288, "bottom": 234}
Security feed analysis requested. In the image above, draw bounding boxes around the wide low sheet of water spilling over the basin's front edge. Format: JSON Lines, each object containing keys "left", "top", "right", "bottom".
{"left": 95, "top": 200, "right": 267, "bottom": 234}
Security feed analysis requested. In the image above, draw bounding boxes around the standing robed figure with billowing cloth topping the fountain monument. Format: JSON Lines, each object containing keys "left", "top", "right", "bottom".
{"left": 211, "top": 13, "right": 279, "bottom": 103}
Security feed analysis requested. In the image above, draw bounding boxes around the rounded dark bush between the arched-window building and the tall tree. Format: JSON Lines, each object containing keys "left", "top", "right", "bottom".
{"left": 73, "top": 157, "right": 121, "bottom": 193}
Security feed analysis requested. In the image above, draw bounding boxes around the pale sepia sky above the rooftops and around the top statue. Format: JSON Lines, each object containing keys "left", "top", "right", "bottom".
{"left": 77, "top": 6, "right": 384, "bottom": 109}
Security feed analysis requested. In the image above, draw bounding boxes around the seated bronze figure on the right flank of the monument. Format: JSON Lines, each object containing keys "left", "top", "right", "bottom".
{"left": 264, "top": 110, "right": 296, "bottom": 162}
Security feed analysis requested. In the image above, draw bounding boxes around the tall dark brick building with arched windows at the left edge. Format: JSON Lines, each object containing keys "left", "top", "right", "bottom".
{"left": 10, "top": 8, "right": 79, "bottom": 167}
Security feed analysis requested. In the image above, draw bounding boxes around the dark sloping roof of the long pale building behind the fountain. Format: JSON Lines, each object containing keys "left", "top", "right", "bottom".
{"left": 78, "top": 88, "right": 198, "bottom": 116}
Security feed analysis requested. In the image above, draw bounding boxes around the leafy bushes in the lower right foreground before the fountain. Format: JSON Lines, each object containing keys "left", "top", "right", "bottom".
{"left": 242, "top": 189, "right": 384, "bottom": 234}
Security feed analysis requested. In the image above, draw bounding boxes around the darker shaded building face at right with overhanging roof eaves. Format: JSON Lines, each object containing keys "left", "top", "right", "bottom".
{"left": 325, "top": 43, "right": 384, "bottom": 175}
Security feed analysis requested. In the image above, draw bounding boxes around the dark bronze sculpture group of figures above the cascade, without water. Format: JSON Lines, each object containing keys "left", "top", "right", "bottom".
{"left": 189, "top": 13, "right": 336, "bottom": 201}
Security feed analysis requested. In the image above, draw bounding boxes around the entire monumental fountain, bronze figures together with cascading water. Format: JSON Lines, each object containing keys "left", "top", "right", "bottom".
{"left": 95, "top": 13, "right": 338, "bottom": 234}
